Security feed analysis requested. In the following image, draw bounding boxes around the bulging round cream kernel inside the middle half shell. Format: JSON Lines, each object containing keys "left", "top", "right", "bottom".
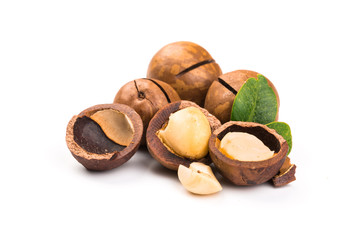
{"left": 157, "top": 107, "right": 211, "bottom": 159}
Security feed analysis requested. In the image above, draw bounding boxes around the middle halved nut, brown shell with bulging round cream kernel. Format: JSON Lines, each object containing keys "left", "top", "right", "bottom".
{"left": 146, "top": 100, "right": 221, "bottom": 170}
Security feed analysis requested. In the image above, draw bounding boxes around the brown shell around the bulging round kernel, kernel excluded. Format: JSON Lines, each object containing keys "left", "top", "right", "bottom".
{"left": 146, "top": 100, "right": 221, "bottom": 171}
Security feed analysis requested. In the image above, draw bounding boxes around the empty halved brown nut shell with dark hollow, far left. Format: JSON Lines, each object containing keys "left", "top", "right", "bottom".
{"left": 66, "top": 104, "right": 143, "bottom": 171}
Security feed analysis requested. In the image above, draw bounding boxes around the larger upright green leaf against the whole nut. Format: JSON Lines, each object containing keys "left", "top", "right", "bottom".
{"left": 231, "top": 74, "right": 278, "bottom": 124}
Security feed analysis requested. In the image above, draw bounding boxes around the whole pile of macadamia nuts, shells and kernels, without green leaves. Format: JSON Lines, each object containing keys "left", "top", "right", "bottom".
{"left": 66, "top": 42, "right": 296, "bottom": 194}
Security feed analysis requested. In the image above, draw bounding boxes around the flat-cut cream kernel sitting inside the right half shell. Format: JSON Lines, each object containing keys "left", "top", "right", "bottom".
{"left": 220, "top": 132, "right": 274, "bottom": 161}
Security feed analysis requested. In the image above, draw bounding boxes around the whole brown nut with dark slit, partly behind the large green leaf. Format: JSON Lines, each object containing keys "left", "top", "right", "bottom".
{"left": 204, "top": 70, "right": 280, "bottom": 123}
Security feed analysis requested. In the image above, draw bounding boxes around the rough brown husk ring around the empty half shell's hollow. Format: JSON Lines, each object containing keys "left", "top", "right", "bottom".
{"left": 66, "top": 104, "right": 143, "bottom": 171}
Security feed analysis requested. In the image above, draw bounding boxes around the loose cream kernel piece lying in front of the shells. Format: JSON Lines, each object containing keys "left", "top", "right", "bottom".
{"left": 178, "top": 162, "right": 222, "bottom": 194}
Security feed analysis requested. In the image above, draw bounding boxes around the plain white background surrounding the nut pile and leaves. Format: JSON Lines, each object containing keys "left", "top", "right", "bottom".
{"left": 0, "top": 0, "right": 360, "bottom": 239}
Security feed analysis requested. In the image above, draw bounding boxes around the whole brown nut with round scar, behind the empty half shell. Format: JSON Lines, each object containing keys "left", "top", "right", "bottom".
{"left": 114, "top": 78, "right": 180, "bottom": 145}
